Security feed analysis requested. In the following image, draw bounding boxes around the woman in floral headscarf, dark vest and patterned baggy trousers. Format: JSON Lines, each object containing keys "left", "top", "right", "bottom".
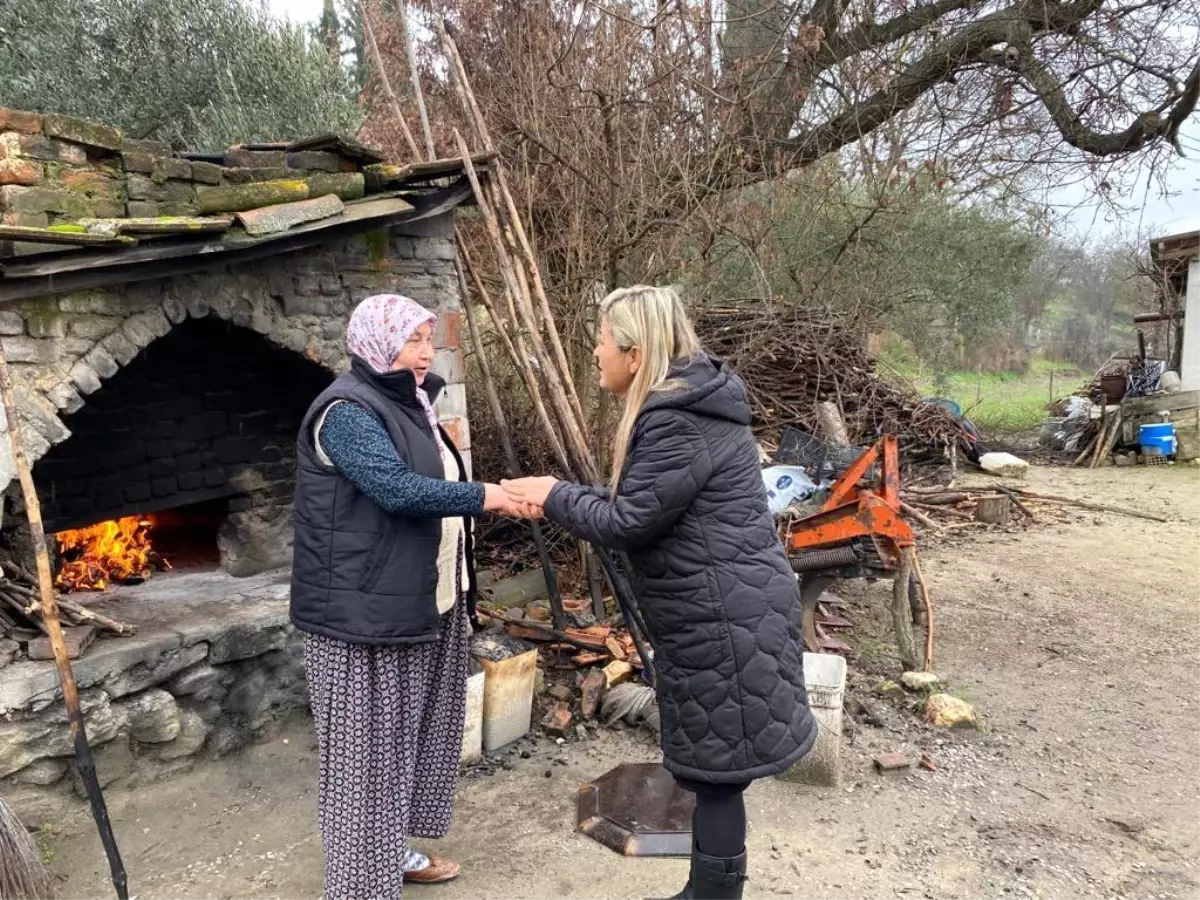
{"left": 292, "top": 294, "right": 523, "bottom": 900}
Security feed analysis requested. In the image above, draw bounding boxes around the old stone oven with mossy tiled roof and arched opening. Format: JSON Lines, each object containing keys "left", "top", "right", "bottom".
{"left": 0, "top": 110, "right": 477, "bottom": 822}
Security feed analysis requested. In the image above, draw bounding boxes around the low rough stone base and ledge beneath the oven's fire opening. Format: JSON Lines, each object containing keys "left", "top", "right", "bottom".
{"left": 0, "top": 571, "right": 307, "bottom": 827}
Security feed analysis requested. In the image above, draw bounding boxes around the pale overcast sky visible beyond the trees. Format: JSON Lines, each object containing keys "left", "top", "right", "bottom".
{"left": 266, "top": 0, "right": 1200, "bottom": 244}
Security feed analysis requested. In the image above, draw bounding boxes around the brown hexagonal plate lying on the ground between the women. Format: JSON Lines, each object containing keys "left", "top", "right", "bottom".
{"left": 576, "top": 763, "right": 696, "bottom": 857}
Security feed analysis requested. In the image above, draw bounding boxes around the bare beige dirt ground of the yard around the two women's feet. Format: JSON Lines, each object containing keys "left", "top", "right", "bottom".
{"left": 46, "top": 468, "right": 1200, "bottom": 900}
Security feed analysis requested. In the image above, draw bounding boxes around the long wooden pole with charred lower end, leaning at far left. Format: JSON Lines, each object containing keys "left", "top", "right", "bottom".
{"left": 0, "top": 347, "right": 130, "bottom": 900}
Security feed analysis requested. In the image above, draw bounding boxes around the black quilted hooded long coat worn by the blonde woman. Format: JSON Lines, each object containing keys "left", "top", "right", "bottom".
{"left": 545, "top": 358, "right": 816, "bottom": 782}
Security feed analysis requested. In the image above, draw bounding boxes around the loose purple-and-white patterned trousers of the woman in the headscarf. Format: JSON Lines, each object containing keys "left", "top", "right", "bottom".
{"left": 305, "top": 601, "right": 470, "bottom": 900}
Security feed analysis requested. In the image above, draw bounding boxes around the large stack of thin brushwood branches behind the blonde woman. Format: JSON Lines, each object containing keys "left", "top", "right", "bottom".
{"left": 696, "top": 304, "right": 970, "bottom": 456}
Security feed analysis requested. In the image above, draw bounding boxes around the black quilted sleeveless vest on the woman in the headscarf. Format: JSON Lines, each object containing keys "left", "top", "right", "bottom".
{"left": 292, "top": 359, "right": 475, "bottom": 644}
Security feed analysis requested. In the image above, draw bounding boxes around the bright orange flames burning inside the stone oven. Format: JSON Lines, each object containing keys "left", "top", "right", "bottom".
{"left": 54, "top": 516, "right": 170, "bottom": 590}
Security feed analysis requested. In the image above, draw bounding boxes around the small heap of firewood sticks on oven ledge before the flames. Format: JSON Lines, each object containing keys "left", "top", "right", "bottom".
{"left": 0, "top": 557, "right": 137, "bottom": 659}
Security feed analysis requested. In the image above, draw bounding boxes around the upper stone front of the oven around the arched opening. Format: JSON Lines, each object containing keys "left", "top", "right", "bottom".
{"left": 0, "top": 215, "right": 470, "bottom": 535}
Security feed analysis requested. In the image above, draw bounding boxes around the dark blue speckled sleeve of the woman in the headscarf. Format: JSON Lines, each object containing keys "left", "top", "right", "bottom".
{"left": 318, "top": 402, "right": 484, "bottom": 518}
